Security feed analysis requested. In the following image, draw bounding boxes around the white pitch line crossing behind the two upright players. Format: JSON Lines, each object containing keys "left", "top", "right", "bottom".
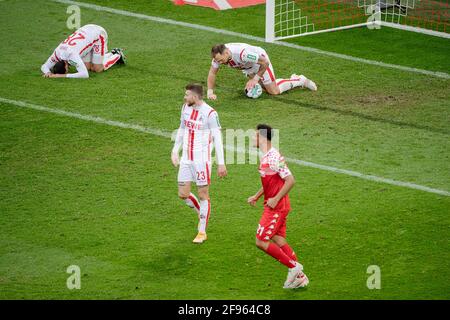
{"left": 0, "top": 97, "right": 450, "bottom": 197}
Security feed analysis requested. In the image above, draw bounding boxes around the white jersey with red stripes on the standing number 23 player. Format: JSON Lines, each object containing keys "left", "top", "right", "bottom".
{"left": 180, "top": 102, "right": 224, "bottom": 164}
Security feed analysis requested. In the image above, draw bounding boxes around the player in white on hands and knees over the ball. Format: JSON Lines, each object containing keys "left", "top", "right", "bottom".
{"left": 208, "top": 43, "right": 317, "bottom": 100}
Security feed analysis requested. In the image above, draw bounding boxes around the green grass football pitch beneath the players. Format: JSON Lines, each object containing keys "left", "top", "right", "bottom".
{"left": 0, "top": 0, "right": 450, "bottom": 300}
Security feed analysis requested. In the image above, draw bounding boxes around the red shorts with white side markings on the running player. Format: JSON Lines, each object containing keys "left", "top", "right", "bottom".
{"left": 256, "top": 207, "right": 289, "bottom": 241}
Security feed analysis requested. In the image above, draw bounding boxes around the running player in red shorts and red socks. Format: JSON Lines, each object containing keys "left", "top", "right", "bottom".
{"left": 247, "top": 124, "right": 309, "bottom": 289}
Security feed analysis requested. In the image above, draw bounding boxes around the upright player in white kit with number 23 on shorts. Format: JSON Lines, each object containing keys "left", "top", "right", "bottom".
{"left": 172, "top": 84, "right": 227, "bottom": 243}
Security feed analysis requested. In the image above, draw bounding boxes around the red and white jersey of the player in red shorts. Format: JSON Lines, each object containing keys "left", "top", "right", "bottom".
{"left": 259, "top": 148, "right": 292, "bottom": 210}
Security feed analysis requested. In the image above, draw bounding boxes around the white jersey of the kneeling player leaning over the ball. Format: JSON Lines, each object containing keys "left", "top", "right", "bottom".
{"left": 211, "top": 43, "right": 267, "bottom": 70}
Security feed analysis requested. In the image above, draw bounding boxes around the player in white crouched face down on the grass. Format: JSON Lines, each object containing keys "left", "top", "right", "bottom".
{"left": 41, "top": 24, "right": 126, "bottom": 78}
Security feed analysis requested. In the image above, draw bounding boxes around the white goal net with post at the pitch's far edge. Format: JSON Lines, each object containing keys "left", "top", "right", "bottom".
{"left": 266, "top": 0, "right": 450, "bottom": 42}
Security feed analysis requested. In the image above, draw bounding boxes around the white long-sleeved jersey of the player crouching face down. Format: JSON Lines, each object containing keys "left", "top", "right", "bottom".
{"left": 41, "top": 24, "right": 106, "bottom": 78}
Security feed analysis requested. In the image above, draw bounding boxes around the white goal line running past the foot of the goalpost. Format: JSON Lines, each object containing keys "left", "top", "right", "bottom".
{"left": 51, "top": 0, "right": 450, "bottom": 79}
